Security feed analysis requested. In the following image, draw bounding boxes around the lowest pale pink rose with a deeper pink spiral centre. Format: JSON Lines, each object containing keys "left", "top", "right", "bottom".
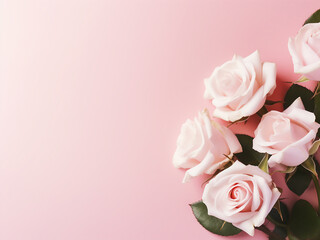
{"left": 202, "top": 161, "right": 280, "bottom": 236}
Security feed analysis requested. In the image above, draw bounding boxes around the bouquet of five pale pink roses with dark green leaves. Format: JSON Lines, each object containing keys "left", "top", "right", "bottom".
{"left": 173, "top": 9, "right": 320, "bottom": 240}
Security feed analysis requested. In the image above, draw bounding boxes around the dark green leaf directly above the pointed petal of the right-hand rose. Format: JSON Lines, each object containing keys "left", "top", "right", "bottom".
{"left": 283, "top": 84, "right": 314, "bottom": 112}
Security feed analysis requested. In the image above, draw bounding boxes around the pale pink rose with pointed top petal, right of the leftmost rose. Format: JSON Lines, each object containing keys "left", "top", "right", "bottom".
{"left": 253, "top": 98, "right": 320, "bottom": 168}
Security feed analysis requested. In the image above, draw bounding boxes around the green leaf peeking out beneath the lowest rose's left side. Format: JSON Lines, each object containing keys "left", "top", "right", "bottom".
{"left": 190, "top": 201, "right": 241, "bottom": 236}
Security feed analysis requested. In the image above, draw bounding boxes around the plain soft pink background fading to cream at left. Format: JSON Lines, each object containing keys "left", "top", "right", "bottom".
{"left": 0, "top": 0, "right": 319, "bottom": 240}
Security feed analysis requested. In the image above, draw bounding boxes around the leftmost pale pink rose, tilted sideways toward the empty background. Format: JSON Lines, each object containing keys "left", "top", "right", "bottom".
{"left": 173, "top": 111, "right": 242, "bottom": 182}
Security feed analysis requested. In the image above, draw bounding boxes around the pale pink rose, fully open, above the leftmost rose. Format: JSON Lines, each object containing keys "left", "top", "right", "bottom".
{"left": 204, "top": 51, "right": 276, "bottom": 122}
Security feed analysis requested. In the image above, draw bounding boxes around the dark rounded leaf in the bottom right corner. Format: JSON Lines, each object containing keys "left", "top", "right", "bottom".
{"left": 289, "top": 200, "right": 320, "bottom": 240}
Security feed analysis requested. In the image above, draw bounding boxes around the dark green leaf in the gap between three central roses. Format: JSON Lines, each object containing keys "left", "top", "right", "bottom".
{"left": 235, "top": 134, "right": 264, "bottom": 166}
